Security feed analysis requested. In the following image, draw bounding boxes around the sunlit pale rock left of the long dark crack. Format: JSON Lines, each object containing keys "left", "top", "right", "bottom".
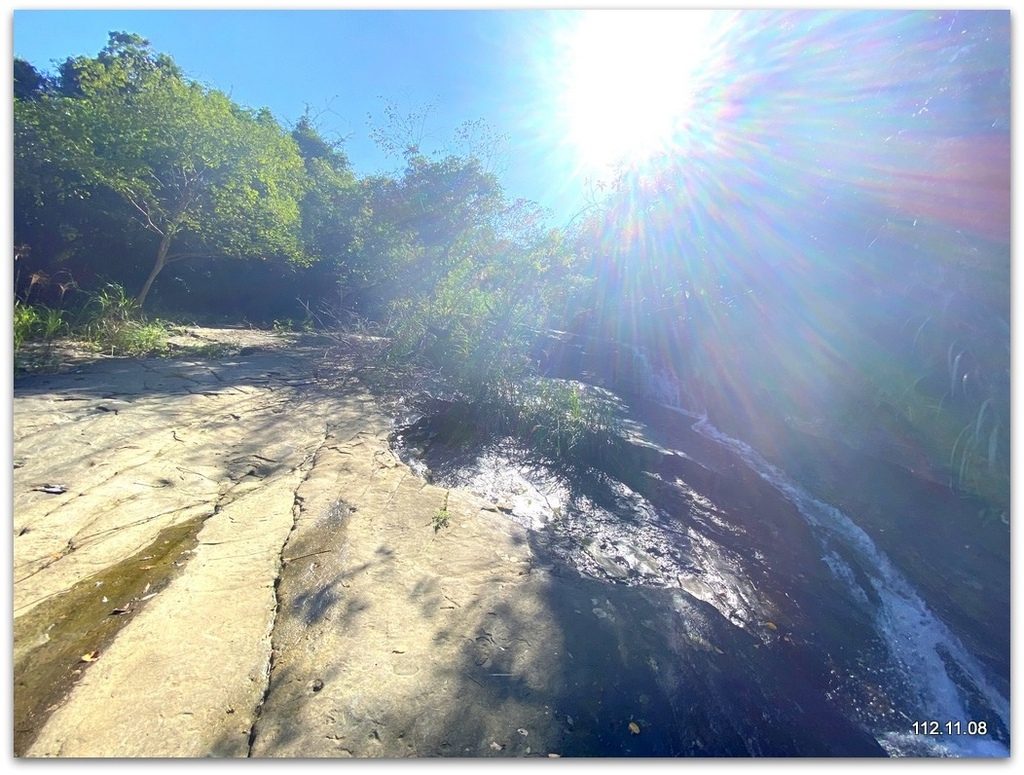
{"left": 13, "top": 331, "right": 383, "bottom": 757}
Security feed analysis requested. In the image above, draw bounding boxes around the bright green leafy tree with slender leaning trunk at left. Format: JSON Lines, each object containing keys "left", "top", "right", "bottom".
{"left": 15, "top": 33, "right": 305, "bottom": 305}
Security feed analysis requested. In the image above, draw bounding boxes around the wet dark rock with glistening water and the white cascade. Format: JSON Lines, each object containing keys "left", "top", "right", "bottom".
{"left": 394, "top": 354, "right": 1010, "bottom": 758}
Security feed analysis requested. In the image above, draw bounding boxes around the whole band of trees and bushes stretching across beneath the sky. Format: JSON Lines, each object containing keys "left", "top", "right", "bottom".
{"left": 13, "top": 28, "right": 1010, "bottom": 520}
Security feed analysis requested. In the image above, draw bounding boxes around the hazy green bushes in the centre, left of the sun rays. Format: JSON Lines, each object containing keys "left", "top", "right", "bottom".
{"left": 364, "top": 115, "right": 622, "bottom": 470}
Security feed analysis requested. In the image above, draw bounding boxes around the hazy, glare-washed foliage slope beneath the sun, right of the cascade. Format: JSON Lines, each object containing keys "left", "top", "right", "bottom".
{"left": 578, "top": 147, "right": 1011, "bottom": 522}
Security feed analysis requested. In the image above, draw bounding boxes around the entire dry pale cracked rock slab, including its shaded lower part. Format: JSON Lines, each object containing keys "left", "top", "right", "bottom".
{"left": 13, "top": 325, "right": 878, "bottom": 758}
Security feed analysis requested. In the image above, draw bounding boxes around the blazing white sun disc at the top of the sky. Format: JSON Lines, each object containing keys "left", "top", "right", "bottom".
{"left": 557, "top": 10, "right": 711, "bottom": 178}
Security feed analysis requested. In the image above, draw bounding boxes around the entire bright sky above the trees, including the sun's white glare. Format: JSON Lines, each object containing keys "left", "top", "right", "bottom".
{"left": 6, "top": 3, "right": 1009, "bottom": 241}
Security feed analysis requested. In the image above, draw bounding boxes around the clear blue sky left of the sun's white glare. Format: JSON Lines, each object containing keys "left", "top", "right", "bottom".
{"left": 13, "top": 9, "right": 606, "bottom": 225}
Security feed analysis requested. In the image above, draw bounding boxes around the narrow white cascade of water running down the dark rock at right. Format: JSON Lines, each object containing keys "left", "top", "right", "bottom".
{"left": 635, "top": 349, "right": 1010, "bottom": 758}
